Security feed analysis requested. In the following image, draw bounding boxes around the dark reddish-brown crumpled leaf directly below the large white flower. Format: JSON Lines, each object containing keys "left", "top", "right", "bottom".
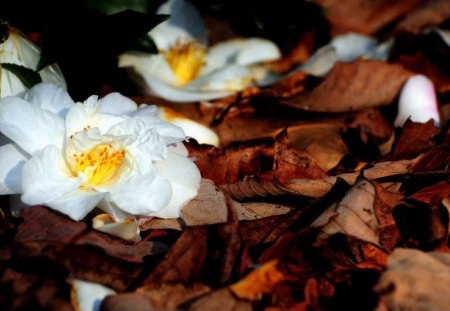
{"left": 11, "top": 206, "right": 166, "bottom": 290}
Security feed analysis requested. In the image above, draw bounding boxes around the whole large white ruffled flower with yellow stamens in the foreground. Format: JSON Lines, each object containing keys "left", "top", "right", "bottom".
{"left": 0, "top": 83, "right": 200, "bottom": 228}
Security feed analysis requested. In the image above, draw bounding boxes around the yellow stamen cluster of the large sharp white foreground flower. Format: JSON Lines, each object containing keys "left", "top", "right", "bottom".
{"left": 73, "top": 144, "right": 126, "bottom": 186}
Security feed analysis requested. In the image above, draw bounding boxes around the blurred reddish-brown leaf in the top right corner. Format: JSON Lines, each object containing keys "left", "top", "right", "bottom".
{"left": 395, "top": 0, "right": 450, "bottom": 35}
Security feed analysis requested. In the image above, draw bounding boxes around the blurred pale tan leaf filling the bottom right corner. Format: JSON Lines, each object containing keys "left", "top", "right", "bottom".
{"left": 374, "top": 248, "right": 450, "bottom": 311}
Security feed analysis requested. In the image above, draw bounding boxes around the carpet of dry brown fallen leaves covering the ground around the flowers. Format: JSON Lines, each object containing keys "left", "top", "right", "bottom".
{"left": 0, "top": 0, "right": 450, "bottom": 311}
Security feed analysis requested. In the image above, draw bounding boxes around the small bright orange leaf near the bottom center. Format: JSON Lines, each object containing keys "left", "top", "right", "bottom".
{"left": 230, "top": 260, "right": 286, "bottom": 300}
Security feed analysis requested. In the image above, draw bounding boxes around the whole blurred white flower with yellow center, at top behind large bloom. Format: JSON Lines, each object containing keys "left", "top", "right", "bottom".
{"left": 119, "top": 0, "right": 281, "bottom": 102}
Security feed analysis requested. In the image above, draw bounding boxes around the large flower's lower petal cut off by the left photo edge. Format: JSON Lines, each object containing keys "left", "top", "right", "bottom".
{"left": 0, "top": 144, "right": 27, "bottom": 195}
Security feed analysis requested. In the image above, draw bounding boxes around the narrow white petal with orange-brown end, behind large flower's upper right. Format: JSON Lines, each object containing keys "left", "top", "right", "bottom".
{"left": 160, "top": 107, "right": 219, "bottom": 146}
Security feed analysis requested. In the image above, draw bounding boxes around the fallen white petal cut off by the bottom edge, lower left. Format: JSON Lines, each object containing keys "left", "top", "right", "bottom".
{"left": 68, "top": 279, "right": 116, "bottom": 311}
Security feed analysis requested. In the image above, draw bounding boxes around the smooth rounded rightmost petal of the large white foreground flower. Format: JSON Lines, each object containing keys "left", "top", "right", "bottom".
{"left": 151, "top": 152, "right": 201, "bottom": 218}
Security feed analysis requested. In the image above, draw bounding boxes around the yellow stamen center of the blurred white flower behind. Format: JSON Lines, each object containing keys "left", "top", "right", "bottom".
{"left": 164, "top": 40, "right": 206, "bottom": 86}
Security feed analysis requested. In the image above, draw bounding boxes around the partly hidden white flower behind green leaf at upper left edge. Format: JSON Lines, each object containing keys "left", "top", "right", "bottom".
{"left": 0, "top": 28, "right": 67, "bottom": 97}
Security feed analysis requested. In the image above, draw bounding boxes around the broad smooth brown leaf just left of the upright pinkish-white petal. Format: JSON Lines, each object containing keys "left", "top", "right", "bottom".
{"left": 282, "top": 60, "right": 413, "bottom": 112}
